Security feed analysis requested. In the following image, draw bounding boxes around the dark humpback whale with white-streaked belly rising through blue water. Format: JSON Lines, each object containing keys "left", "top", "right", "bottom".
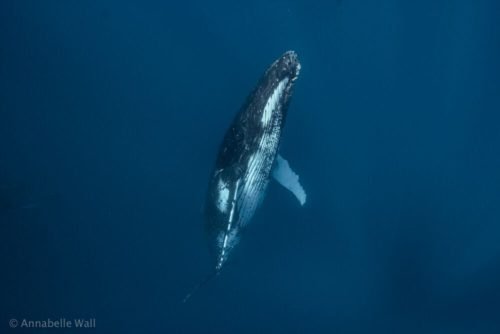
{"left": 184, "top": 51, "right": 306, "bottom": 301}
